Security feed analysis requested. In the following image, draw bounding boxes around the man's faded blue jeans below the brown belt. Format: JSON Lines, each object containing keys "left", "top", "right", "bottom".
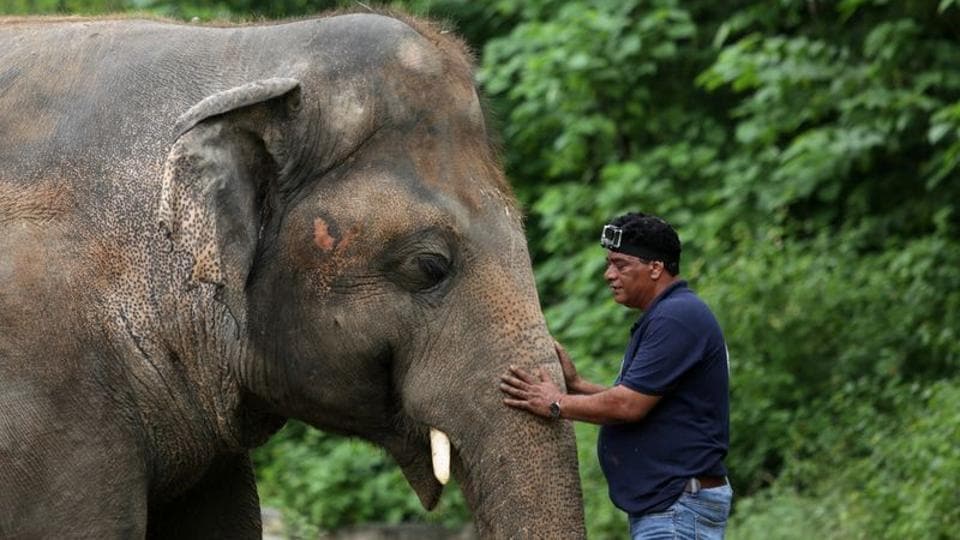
{"left": 630, "top": 483, "right": 733, "bottom": 540}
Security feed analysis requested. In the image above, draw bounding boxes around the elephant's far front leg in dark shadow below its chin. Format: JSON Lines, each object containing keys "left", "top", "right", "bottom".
{"left": 147, "top": 453, "right": 261, "bottom": 540}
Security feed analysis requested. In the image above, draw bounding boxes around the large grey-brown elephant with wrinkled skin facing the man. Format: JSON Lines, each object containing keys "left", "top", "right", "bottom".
{"left": 0, "top": 14, "right": 584, "bottom": 538}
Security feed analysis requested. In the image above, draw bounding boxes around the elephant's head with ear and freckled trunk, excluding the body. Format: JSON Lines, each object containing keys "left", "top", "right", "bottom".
{"left": 160, "top": 15, "right": 584, "bottom": 538}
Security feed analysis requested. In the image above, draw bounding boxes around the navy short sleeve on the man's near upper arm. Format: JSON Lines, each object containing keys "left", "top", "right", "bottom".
{"left": 620, "top": 317, "right": 702, "bottom": 396}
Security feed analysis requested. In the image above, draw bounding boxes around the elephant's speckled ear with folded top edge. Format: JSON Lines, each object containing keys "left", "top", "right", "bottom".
{"left": 159, "top": 78, "right": 300, "bottom": 316}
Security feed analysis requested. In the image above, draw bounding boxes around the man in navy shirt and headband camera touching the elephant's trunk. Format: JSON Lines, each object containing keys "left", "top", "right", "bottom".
{"left": 501, "top": 213, "right": 733, "bottom": 539}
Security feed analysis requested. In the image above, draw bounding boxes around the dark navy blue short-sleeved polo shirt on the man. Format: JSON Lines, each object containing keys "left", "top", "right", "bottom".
{"left": 598, "top": 281, "right": 729, "bottom": 514}
